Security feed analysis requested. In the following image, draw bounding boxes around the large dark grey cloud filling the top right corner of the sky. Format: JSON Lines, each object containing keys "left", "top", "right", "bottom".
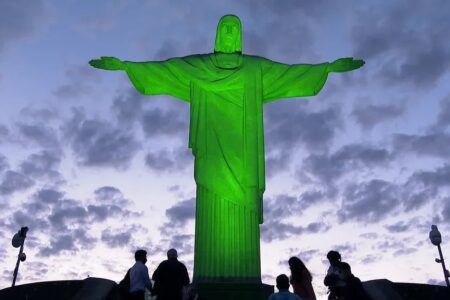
{"left": 353, "top": 1, "right": 450, "bottom": 87}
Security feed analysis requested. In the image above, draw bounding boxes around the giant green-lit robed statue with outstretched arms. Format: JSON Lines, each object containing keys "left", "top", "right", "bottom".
{"left": 89, "top": 15, "right": 364, "bottom": 283}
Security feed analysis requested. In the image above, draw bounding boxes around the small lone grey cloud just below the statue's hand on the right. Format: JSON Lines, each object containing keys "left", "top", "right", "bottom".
{"left": 352, "top": 104, "right": 404, "bottom": 130}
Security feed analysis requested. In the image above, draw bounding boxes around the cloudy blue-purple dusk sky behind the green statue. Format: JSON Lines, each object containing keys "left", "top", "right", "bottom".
{"left": 0, "top": 0, "right": 450, "bottom": 295}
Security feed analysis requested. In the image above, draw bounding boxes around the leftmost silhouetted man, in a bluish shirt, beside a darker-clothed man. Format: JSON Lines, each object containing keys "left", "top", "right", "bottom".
{"left": 129, "top": 250, "right": 152, "bottom": 300}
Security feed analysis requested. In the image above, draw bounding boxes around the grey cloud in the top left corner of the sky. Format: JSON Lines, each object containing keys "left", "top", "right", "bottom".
{"left": 0, "top": 0, "right": 46, "bottom": 51}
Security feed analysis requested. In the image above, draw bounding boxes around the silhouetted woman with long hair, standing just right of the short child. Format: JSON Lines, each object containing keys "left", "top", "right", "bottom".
{"left": 288, "top": 256, "right": 316, "bottom": 300}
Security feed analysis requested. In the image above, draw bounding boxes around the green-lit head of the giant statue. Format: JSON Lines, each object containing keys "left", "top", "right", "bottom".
{"left": 214, "top": 15, "right": 242, "bottom": 53}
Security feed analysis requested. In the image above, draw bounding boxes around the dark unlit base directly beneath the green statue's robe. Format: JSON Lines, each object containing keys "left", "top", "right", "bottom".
{"left": 194, "top": 282, "right": 274, "bottom": 300}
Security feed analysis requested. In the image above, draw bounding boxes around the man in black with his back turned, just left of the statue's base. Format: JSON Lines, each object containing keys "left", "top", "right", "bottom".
{"left": 152, "top": 249, "right": 189, "bottom": 300}
